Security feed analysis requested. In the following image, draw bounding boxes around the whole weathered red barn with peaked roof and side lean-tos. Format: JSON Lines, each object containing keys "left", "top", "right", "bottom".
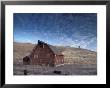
{"left": 23, "top": 40, "right": 64, "bottom": 66}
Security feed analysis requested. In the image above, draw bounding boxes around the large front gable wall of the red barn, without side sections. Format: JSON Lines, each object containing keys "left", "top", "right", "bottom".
{"left": 31, "top": 44, "right": 54, "bottom": 65}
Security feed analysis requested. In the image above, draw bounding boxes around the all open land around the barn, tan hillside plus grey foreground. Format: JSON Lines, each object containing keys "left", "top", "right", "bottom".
{"left": 13, "top": 42, "right": 97, "bottom": 75}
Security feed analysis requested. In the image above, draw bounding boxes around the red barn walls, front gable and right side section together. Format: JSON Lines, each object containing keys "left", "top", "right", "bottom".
{"left": 30, "top": 44, "right": 64, "bottom": 66}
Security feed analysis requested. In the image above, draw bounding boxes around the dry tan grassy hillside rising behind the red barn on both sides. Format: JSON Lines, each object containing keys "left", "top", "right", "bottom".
{"left": 13, "top": 42, "right": 97, "bottom": 64}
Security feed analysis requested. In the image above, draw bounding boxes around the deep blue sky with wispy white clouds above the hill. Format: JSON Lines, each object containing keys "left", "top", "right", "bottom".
{"left": 14, "top": 13, "right": 97, "bottom": 51}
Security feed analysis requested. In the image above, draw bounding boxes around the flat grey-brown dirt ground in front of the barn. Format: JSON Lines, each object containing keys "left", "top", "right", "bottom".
{"left": 13, "top": 64, "right": 97, "bottom": 75}
